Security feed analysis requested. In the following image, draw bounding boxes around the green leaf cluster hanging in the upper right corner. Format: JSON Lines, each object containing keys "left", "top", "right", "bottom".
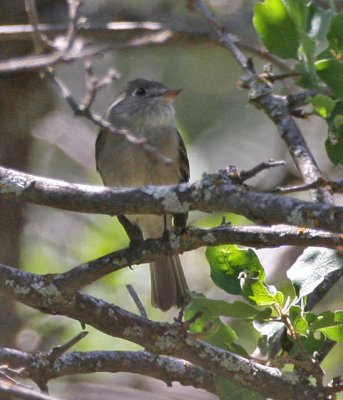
{"left": 253, "top": 0, "right": 343, "bottom": 165}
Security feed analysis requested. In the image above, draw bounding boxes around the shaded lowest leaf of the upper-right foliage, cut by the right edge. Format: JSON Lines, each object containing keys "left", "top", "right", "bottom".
{"left": 325, "top": 101, "right": 343, "bottom": 165}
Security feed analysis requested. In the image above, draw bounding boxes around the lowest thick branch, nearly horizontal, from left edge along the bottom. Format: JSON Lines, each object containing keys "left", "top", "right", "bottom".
{"left": 0, "top": 348, "right": 215, "bottom": 393}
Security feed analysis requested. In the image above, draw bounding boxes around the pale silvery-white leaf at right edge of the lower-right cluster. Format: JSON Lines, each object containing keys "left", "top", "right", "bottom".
{"left": 287, "top": 247, "right": 343, "bottom": 299}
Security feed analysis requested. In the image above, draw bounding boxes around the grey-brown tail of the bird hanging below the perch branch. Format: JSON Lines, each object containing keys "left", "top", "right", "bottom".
{"left": 150, "top": 255, "right": 189, "bottom": 311}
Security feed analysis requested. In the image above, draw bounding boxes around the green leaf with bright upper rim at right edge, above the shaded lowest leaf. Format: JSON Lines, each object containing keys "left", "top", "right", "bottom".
{"left": 315, "top": 58, "right": 343, "bottom": 100}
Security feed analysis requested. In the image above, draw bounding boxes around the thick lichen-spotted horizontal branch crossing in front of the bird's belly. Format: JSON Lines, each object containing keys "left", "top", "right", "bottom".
{"left": 0, "top": 167, "right": 343, "bottom": 232}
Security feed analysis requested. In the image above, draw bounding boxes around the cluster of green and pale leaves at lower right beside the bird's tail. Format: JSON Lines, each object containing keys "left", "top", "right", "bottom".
{"left": 186, "top": 245, "right": 343, "bottom": 399}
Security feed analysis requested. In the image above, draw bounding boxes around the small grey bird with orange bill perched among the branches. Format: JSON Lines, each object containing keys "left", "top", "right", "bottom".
{"left": 96, "top": 79, "right": 189, "bottom": 311}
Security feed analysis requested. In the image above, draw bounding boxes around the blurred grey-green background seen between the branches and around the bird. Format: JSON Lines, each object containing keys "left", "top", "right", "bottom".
{"left": 0, "top": 0, "right": 342, "bottom": 399}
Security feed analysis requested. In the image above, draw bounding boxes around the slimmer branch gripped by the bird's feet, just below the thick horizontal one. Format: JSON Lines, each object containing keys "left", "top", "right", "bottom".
{"left": 50, "top": 226, "right": 343, "bottom": 293}
